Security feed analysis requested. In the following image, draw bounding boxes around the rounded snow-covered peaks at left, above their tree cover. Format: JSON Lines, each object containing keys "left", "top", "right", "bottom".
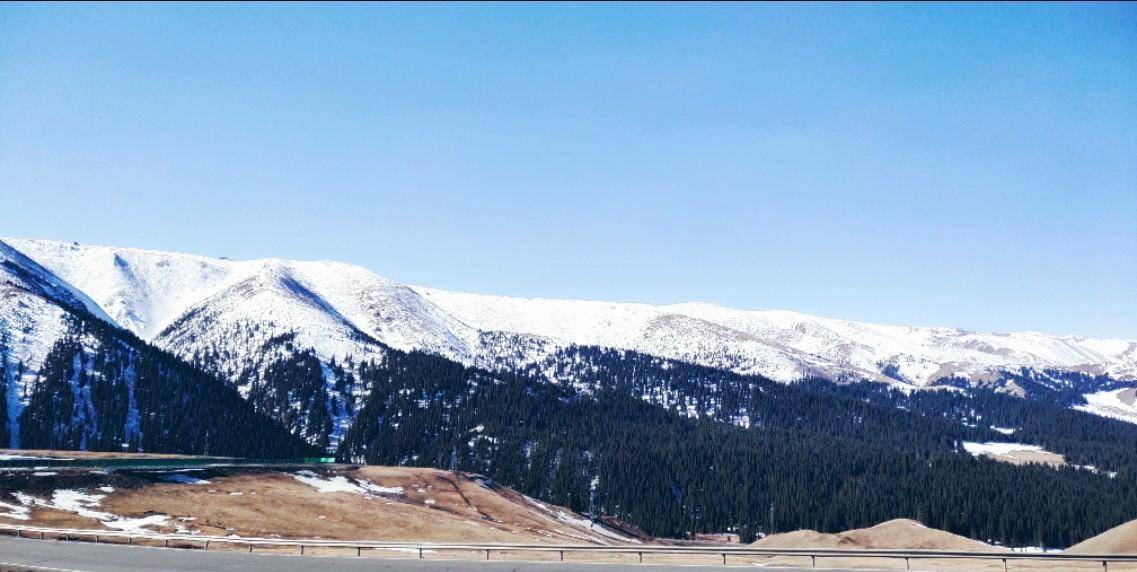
{"left": 3, "top": 239, "right": 478, "bottom": 360}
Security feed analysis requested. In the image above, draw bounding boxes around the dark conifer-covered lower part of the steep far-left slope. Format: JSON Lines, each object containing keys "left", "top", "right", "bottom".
{"left": 0, "top": 315, "right": 313, "bottom": 457}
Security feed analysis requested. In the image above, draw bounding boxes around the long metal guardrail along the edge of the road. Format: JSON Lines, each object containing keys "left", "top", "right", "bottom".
{"left": 0, "top": 524, "right": 1137, "bottom": 572}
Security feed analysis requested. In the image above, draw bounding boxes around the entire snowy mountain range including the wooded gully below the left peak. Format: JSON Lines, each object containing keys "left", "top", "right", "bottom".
{"left": 9, "top": 239, "right": 1137, "bottom": 436}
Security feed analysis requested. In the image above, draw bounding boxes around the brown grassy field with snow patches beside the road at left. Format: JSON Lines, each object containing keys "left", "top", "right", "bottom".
{"left": 0, "top": 465, "right": 644, "bottom": 544}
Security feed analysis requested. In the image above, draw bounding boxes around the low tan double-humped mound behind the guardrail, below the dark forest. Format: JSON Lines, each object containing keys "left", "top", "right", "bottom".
{"left": 750, "top": 519, "right": 997, "bottom": 552}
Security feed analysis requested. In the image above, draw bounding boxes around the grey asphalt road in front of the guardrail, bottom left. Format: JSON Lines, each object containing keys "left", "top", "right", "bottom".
{"left": 0, "top": 537, "right": 832, "bottom": 572}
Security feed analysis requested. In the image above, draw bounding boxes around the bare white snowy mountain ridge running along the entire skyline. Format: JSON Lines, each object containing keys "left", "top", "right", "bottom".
{"left": 2, "top": 239, "right": 1137, "bottom": 387}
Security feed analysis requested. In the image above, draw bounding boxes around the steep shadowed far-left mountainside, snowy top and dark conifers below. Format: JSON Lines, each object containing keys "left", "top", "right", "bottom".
{"left": 0, "top": 242, "right": 308, "bottom": 456}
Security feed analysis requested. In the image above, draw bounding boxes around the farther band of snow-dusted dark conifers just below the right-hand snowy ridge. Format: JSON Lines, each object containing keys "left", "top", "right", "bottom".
{"left": 528, "top": 347, "right": 1137, "bottom": 470}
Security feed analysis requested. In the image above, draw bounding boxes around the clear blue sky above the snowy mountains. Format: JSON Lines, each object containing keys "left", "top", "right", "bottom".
{"left": 0, "top": 3, "right": 1137, "bottom": 338}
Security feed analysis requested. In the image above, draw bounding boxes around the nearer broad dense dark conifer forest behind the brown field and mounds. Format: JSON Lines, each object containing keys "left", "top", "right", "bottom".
{"left": 339, "top": 351, "right": 1137, "bottom": 546}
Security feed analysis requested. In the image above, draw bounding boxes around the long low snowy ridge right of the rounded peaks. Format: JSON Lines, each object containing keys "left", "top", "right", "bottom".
{"left": 415, "top": 287, "right": 1137, "bottom": 386}
